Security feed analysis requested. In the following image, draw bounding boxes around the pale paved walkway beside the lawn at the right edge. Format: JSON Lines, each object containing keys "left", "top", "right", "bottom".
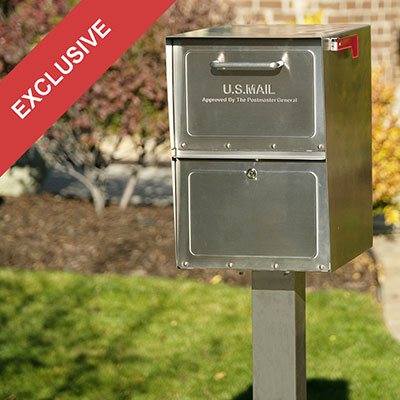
{"left": 373, "top": 233, "right": 400, "bottom": 340}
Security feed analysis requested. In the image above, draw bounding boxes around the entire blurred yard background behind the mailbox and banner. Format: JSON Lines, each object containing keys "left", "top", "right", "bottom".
{"left": 0, "top": 0, "right": 400, "bottom": 400}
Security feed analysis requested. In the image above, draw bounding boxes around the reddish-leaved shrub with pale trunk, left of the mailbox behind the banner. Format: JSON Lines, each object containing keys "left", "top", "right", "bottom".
{"left": 0, "top": 0, "right": 233, "bottom": 213}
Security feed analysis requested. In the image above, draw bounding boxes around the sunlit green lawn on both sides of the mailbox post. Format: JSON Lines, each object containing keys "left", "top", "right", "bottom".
{"left": 0, "top": 269, "right": 400, "bottom": 400}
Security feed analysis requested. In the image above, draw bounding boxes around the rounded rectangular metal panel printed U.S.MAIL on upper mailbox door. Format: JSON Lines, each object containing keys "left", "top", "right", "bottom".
{"left": 184, "top": 47, "right": 316, "bottom": 138}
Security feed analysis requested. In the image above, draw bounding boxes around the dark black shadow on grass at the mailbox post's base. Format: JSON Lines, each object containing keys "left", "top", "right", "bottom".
{"left": 232, "top": 379, "right": 349, "bottom": 400}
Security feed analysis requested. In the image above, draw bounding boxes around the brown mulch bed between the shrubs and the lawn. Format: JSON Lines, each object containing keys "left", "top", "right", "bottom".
{"left": 0, "top": 195, "right": 377, "bottom": 291}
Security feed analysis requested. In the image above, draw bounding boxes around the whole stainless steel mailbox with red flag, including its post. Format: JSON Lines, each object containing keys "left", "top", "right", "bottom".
{"left": 167, "top": 25, "right": 372, "bottom": 400}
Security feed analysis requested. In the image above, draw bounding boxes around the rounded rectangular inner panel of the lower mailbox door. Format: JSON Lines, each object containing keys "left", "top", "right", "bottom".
{"left": 188, "top": 166, "right": 318, "bottom": 259}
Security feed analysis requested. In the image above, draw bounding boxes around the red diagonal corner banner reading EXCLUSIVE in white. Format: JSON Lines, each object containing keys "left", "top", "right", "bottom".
{"left": 0, "top": 0, "right": 174, "bottom": 176}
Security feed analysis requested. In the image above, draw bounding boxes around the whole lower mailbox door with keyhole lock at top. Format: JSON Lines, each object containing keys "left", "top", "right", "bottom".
{"left": 176, "top": 160, "right": 329, "bottom": 270}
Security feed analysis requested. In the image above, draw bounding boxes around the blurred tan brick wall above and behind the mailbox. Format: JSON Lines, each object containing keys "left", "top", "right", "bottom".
{"left": 232, "top": 0, "right": 400, "bottom": 84}
